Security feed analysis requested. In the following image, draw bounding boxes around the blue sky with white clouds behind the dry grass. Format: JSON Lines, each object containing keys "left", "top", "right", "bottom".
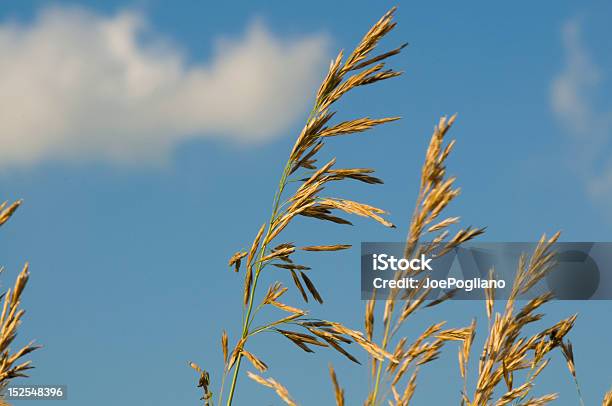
{"left": 0, "top": 1, "right": 612, "bottom": 406}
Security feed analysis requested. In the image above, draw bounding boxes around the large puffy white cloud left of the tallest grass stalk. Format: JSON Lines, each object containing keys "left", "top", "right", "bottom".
{"left": 0, "top": 8, "right": 327, "bottom": 166}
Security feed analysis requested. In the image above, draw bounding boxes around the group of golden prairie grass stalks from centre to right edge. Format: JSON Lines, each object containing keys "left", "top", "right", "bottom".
{"left": 190, "top": 8, "right": 612, "bottom": 406}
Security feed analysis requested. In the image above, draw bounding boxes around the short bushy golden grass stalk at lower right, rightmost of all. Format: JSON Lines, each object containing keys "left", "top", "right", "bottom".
{"left": 464, "top": 233, "right": 582, "bottom": 405}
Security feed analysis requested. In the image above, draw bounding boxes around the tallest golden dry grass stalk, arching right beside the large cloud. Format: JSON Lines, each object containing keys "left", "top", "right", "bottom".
{"left": 190, "top": 9, "right": 412, "bottom": 405}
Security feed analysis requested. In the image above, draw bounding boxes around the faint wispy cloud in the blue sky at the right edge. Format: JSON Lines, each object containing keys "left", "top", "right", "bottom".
{"left": 551, "top": 19, "right": 612, "bottom": 202}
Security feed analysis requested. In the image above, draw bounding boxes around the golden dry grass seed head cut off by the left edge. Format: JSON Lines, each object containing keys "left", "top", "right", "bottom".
{"left": 0, "top": 200, "right": 39, "bottom": 390}
